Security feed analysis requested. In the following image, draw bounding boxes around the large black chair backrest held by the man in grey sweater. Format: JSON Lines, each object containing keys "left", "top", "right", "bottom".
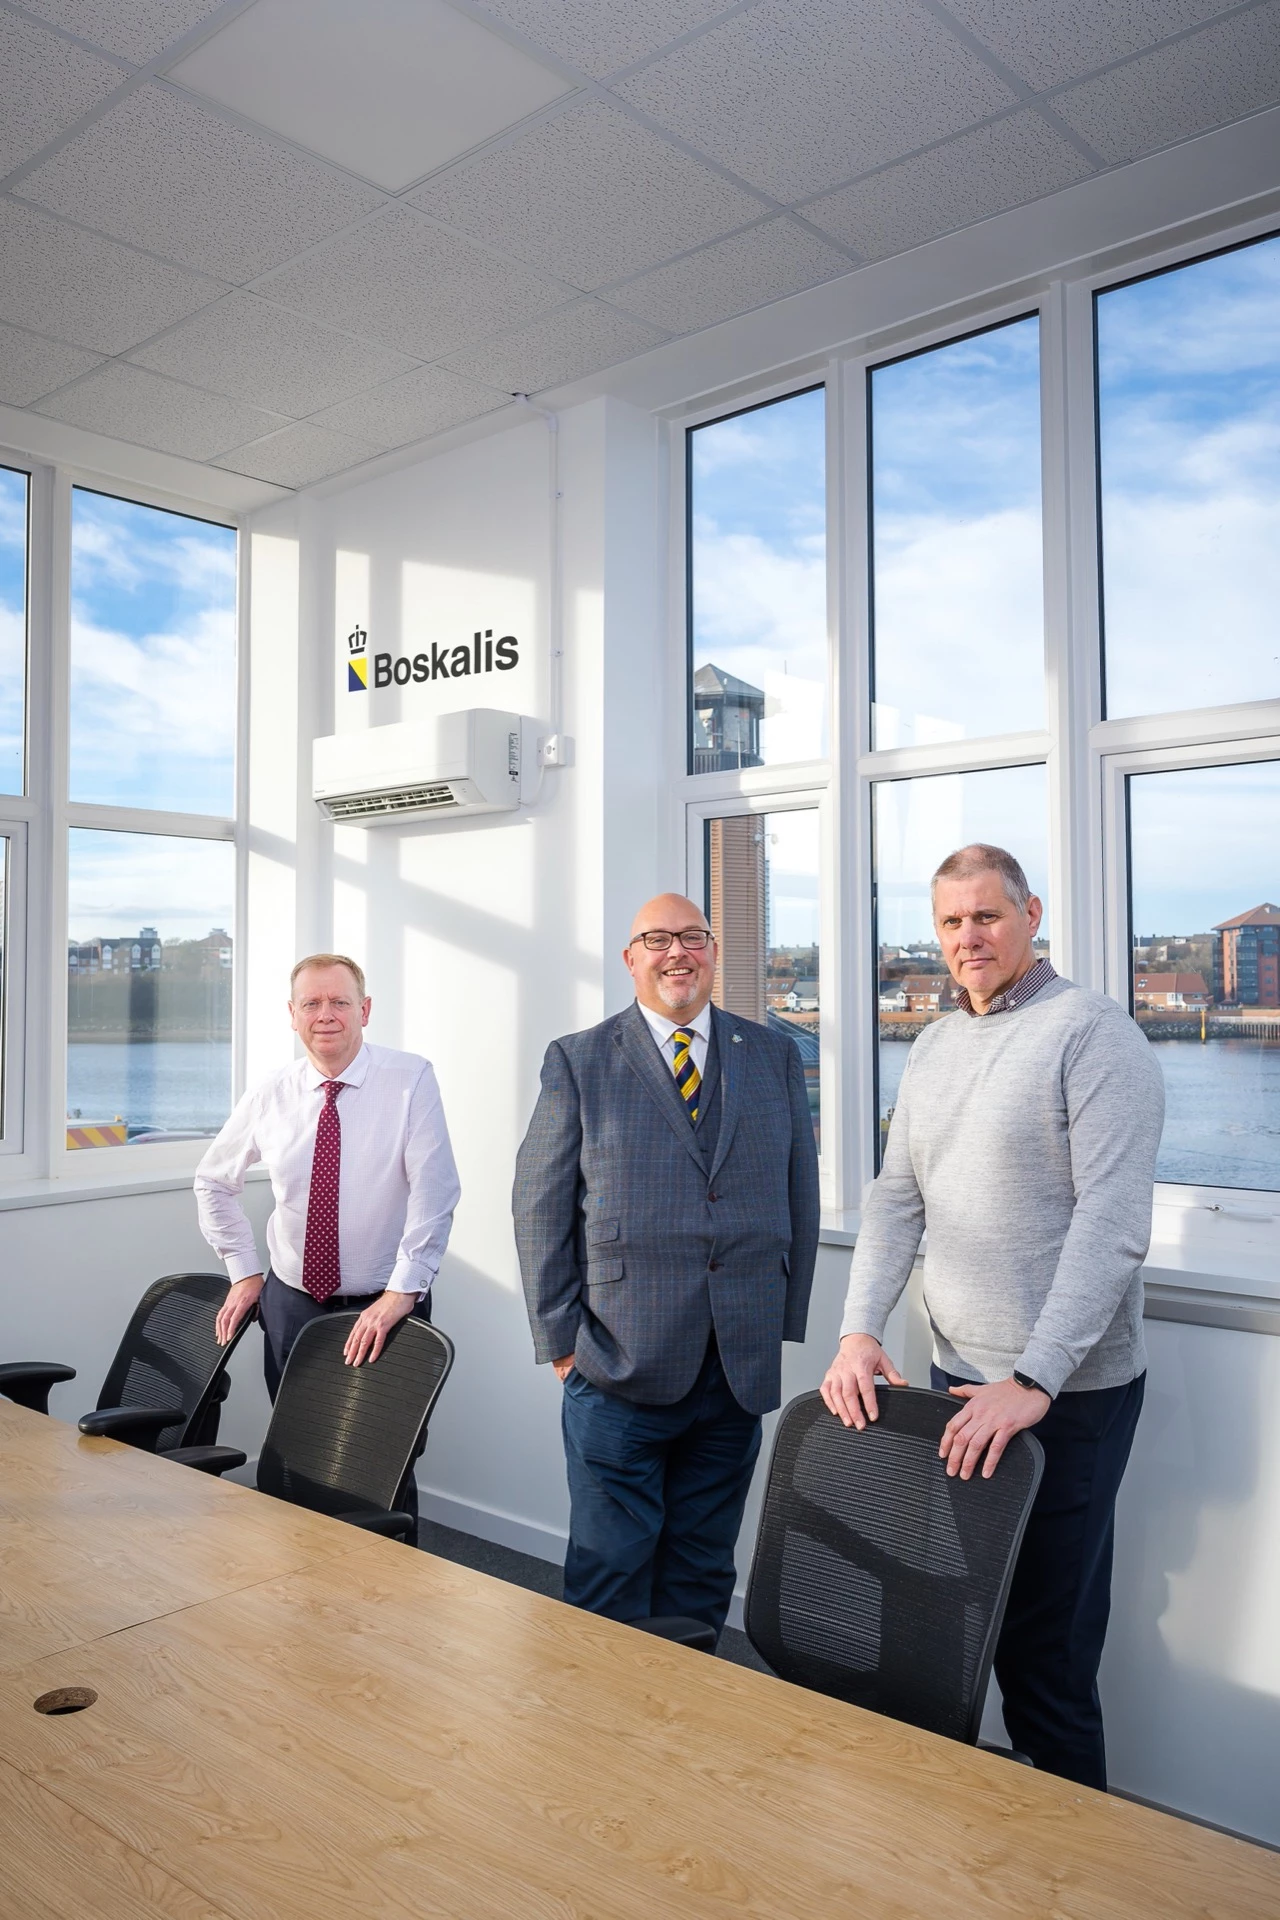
{"left": 745, "top": 1386, "right": 1044, "bottom": 1741}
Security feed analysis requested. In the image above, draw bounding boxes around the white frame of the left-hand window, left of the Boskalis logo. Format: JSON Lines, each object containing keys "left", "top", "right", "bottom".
{"left": 0, "top": 447, "right": 249, "bottom": 1202}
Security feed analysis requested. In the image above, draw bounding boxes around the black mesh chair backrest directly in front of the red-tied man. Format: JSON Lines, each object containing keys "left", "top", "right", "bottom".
{"left": 257, "top": 1313, "right": 453, "bottom": 1513}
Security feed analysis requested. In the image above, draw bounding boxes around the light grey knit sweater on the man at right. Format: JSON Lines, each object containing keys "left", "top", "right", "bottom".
{"left": 841, "top": 979, "right": 1165, "bottom": 1394}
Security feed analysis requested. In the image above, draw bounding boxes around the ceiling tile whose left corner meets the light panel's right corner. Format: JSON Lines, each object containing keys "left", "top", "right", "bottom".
{"left": 616, "top": 0, "right": 1015, "bottom": 202}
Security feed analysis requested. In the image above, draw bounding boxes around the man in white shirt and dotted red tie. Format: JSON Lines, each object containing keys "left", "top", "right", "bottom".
{"left": 196, "top": 954, "right": 459, "bottom": 1400}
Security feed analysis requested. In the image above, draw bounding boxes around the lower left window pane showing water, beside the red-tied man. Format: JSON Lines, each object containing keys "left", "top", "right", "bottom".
{"left": 67, "top": 828, "right": 236, "bottom": 1150}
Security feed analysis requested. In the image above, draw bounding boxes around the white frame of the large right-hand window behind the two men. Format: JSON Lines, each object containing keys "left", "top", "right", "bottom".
{"left": 666, "top": 202, "right": 1280, "bottom": 1292}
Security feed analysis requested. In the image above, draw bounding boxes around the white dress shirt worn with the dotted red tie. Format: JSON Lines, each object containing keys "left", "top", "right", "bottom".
{"left": 196, "top": 1046, "right": 461, "bottom": 1294}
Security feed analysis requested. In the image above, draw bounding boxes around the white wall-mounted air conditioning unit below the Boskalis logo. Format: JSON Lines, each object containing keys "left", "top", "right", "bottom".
{"left": 311, "top": 707, "right": 545, "bottom": 826}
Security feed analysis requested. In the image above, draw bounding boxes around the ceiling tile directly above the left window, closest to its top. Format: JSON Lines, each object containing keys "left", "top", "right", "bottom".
{"left": 35, "top": 361, "right": 280, "bottom": 461}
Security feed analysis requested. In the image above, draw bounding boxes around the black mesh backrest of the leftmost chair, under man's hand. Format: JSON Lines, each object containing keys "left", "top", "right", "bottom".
{"left": 98, "top": 1273, "right": 248, "bottom": 1453}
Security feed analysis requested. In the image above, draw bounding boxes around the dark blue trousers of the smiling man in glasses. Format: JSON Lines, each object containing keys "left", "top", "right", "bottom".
{"left": 562, "top": 1340, "right": 760, "bottom": 1632}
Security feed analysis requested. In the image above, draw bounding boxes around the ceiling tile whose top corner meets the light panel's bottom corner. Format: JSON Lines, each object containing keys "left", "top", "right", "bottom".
{"left": 259, "top": 205, "right": 566, "bottom": 359}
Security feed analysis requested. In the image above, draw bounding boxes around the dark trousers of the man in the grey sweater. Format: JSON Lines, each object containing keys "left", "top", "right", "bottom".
{"left": 931, "top": 1367, "right": 1146, "bottom": 1793}
